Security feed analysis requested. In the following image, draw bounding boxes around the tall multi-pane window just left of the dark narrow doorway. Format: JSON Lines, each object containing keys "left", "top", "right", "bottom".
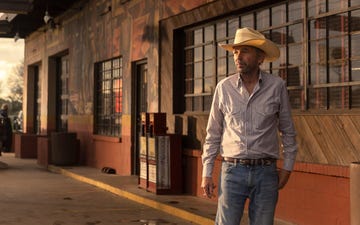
{"left": 94, "top": 58, "right": 123, "bottom": 137}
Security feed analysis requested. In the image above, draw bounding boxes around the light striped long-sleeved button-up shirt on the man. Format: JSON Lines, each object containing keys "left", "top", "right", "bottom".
{"left": 202, "top": 71, "right": 297, "bottom": 177}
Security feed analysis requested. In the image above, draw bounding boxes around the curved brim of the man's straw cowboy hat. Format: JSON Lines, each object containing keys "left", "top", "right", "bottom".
{"left": 219, "top": 39, "right": 280, "bottom": 62}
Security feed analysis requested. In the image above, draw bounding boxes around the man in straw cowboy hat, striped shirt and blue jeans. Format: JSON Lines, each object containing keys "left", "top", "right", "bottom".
{"left": 201, "top": 28, "right": 297, "bottom": 225}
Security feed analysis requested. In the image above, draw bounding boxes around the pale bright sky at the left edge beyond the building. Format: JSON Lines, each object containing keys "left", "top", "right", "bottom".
{"left": 0, "top": 38, "right": 24, "bottom": 98}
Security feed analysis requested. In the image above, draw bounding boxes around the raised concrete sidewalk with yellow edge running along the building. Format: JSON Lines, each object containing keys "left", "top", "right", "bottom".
{"left": 0, "top": 153, "right": 290, "bottom": 225}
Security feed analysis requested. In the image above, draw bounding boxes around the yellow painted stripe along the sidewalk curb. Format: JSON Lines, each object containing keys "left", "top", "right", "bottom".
{"left": 48, "top": 165, "right": 214, "bottom": 225}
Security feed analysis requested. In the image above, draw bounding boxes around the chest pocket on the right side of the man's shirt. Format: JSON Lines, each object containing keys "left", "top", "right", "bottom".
{"left": 253, "top": 102, "right": 279, "bottom": 130}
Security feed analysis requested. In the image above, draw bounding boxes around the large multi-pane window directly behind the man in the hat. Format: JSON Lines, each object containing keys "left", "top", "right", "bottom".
{"left": 184, "top": 0, "right": 360, "bottom": 112}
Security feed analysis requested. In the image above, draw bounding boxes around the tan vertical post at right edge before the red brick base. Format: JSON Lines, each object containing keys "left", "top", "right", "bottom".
{"left": 350, "top": 162, "right": 360, "bottom": 225}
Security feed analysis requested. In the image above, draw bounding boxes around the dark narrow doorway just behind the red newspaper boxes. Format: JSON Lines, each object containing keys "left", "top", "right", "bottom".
{"left": 131, "top": 60, "right": 148, "bottom": 175}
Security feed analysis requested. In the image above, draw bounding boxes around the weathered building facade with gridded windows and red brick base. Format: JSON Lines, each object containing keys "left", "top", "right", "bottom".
{"left": 12, "top": 0, "right": 360, "bottom": 225}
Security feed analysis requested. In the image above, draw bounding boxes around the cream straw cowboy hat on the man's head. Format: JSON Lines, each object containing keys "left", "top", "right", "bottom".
{"left": 219, "top": 27, "right": 280, "bottom": 62}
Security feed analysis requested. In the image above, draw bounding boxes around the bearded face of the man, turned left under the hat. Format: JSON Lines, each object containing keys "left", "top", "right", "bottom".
{"left": 233, "top": 46, "right": 265, "bottom": 74}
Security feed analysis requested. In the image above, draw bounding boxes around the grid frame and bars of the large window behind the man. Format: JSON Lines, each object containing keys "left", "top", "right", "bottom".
{"left": 180, "top": 0, "right": 360, "bottom": 114}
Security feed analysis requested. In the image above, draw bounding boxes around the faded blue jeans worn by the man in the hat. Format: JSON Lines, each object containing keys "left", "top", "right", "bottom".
{"left": 215, "top": 162, "right": 279, "bottom": 225}
